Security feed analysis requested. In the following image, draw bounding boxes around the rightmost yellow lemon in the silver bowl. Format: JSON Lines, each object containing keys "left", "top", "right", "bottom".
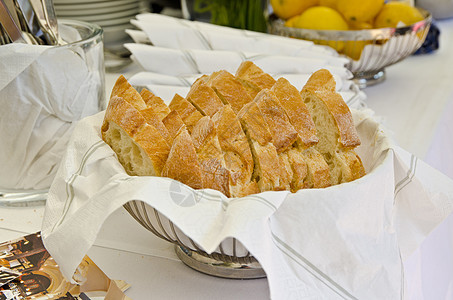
{"left": 374, "top": 2, "right": 423, "bottom": 28}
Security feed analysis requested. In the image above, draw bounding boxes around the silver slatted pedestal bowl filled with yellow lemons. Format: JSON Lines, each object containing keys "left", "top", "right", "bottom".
{"left": 269, "top": 0, "right": 432, "bottom": 88}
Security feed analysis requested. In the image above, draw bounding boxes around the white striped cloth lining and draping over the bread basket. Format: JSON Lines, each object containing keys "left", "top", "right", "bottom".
{"left": 42, "top": 110, "right": 453, "bottom": 299}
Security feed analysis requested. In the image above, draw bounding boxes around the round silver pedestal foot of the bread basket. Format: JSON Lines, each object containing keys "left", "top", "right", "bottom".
{"left": 175, "top": 245, "right": 266, "bottom": 279}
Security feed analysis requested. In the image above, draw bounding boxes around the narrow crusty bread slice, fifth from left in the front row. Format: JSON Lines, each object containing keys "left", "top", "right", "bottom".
{"left": 238, "top": 102, "right": 281, "bottom": 192}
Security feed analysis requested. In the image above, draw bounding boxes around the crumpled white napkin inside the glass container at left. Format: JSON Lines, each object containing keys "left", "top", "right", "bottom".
{"left": 0, "top": 44, "right": 102, "bottom": 189}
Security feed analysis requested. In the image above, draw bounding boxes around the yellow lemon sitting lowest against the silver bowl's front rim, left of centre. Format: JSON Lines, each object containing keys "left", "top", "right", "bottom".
{"left": 293, "top": 6, "right": 349, "bottom": 51}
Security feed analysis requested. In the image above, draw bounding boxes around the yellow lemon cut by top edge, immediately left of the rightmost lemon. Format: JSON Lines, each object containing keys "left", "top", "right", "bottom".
{"left": 337, "top": 0, "right": 384, "bottom": 23}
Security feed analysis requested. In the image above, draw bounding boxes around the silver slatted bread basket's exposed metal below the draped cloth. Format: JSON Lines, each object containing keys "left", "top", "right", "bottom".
{"left": 124, "top": 201, "right": 266, "bottom": 279}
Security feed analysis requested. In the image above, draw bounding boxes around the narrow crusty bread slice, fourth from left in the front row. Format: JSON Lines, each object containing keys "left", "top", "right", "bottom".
{"left": 212, "top": 105, "right": 259, "bottom": 197}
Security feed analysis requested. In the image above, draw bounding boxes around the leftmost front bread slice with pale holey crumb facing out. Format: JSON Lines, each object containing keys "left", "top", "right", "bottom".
{"left": 101, "top": 96, "right": 170, "bottom": 176}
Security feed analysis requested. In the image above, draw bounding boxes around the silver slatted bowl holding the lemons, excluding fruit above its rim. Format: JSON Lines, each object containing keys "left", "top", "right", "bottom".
{"left": 269, "top": 8, "right": 432, "bottom": 88}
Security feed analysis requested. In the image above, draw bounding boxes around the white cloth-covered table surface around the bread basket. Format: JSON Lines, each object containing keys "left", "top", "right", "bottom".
{"left": 0, "top": 19, "right": 453, "bottom": 300}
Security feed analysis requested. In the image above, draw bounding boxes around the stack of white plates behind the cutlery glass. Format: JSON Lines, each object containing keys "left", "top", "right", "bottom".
{"left": 54, "top": 0, "right": 144, "bottom": 48}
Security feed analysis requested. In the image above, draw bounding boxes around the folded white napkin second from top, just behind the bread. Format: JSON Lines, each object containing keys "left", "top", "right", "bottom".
{"left": 124, "top": 43, "right": 350, "bottom": 78}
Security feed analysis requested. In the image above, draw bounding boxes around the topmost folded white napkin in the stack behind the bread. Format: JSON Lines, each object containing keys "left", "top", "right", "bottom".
{"left": 129, "top": 14, "right": 347, "bottom": 63}
